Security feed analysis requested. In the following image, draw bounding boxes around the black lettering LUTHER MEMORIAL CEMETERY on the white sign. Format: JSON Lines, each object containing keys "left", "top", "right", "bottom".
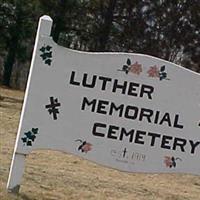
{"left": 70, "top": 71, "right": 200, "bottom": 154}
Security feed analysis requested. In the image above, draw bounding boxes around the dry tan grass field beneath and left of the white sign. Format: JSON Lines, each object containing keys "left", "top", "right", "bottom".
{"left": 0, "top": 87, "right": 200, "bottom": 200}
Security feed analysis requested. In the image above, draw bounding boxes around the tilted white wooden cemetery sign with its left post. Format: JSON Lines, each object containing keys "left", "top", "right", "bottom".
{"left": 7, "top": 16, "right": 200, "bottom": 191}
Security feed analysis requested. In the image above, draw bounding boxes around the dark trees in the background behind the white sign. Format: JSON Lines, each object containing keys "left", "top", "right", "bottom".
{"left": 0, "top": 0, "right": 200, "bottom": 86}
